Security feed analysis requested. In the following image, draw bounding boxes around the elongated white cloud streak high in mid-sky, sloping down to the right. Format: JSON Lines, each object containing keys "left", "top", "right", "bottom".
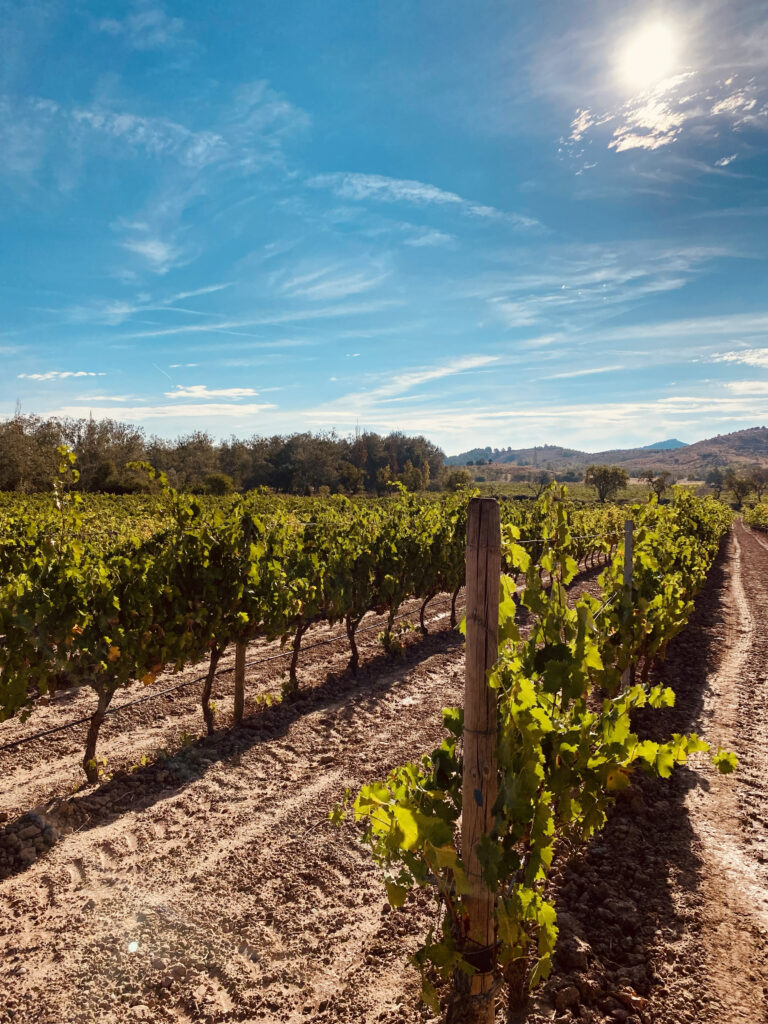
{"left": 307, "top": 171, "right": 540, "bottom": 227}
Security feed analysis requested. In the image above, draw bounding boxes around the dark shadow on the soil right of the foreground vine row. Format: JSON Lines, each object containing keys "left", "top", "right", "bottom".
{"left": 547, "top": 541, "right": 728, "bottom": 1024}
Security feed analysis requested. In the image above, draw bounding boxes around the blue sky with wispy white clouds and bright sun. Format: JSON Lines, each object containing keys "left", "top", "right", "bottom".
{"left": 0, "top": 0, "right": 768, "bottom": 454}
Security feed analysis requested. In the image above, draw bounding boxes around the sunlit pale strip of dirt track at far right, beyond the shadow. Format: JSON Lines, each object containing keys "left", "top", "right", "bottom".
{"left": 687, "top": 522, "right": 768, "bottom": 1024}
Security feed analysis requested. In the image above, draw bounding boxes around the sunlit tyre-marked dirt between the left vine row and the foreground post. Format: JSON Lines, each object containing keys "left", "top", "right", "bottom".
{"left": 0, "top": 630, "right": 461, "bottom": 1024}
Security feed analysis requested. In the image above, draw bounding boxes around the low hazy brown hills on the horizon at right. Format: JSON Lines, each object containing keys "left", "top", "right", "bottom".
{"left": 445, "top": 427, "right": 768, "bottom": 478}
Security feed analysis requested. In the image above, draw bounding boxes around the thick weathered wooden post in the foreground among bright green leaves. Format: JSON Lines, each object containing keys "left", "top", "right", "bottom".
{"left": 462, "top": 498, "right": 502, "bottom": 1024}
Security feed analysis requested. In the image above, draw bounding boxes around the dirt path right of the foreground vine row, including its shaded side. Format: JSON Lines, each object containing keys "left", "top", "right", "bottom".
{"left": 530, "top": 522, "right": 768, "bottom": 1024}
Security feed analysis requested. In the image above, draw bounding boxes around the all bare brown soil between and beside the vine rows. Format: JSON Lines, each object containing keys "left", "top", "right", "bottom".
{"left": 0, "top": 536, "right": 768, "bottom": 1024}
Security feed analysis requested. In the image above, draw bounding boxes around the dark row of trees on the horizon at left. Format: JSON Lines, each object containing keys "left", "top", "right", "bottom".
{"left": 0, "top": 413, "right": 451, "bottom": 495}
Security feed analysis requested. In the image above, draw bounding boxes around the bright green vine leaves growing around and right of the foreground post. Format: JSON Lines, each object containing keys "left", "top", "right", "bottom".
{"left": 342, "top": 489, "right": 736, "bottom": 1002}
